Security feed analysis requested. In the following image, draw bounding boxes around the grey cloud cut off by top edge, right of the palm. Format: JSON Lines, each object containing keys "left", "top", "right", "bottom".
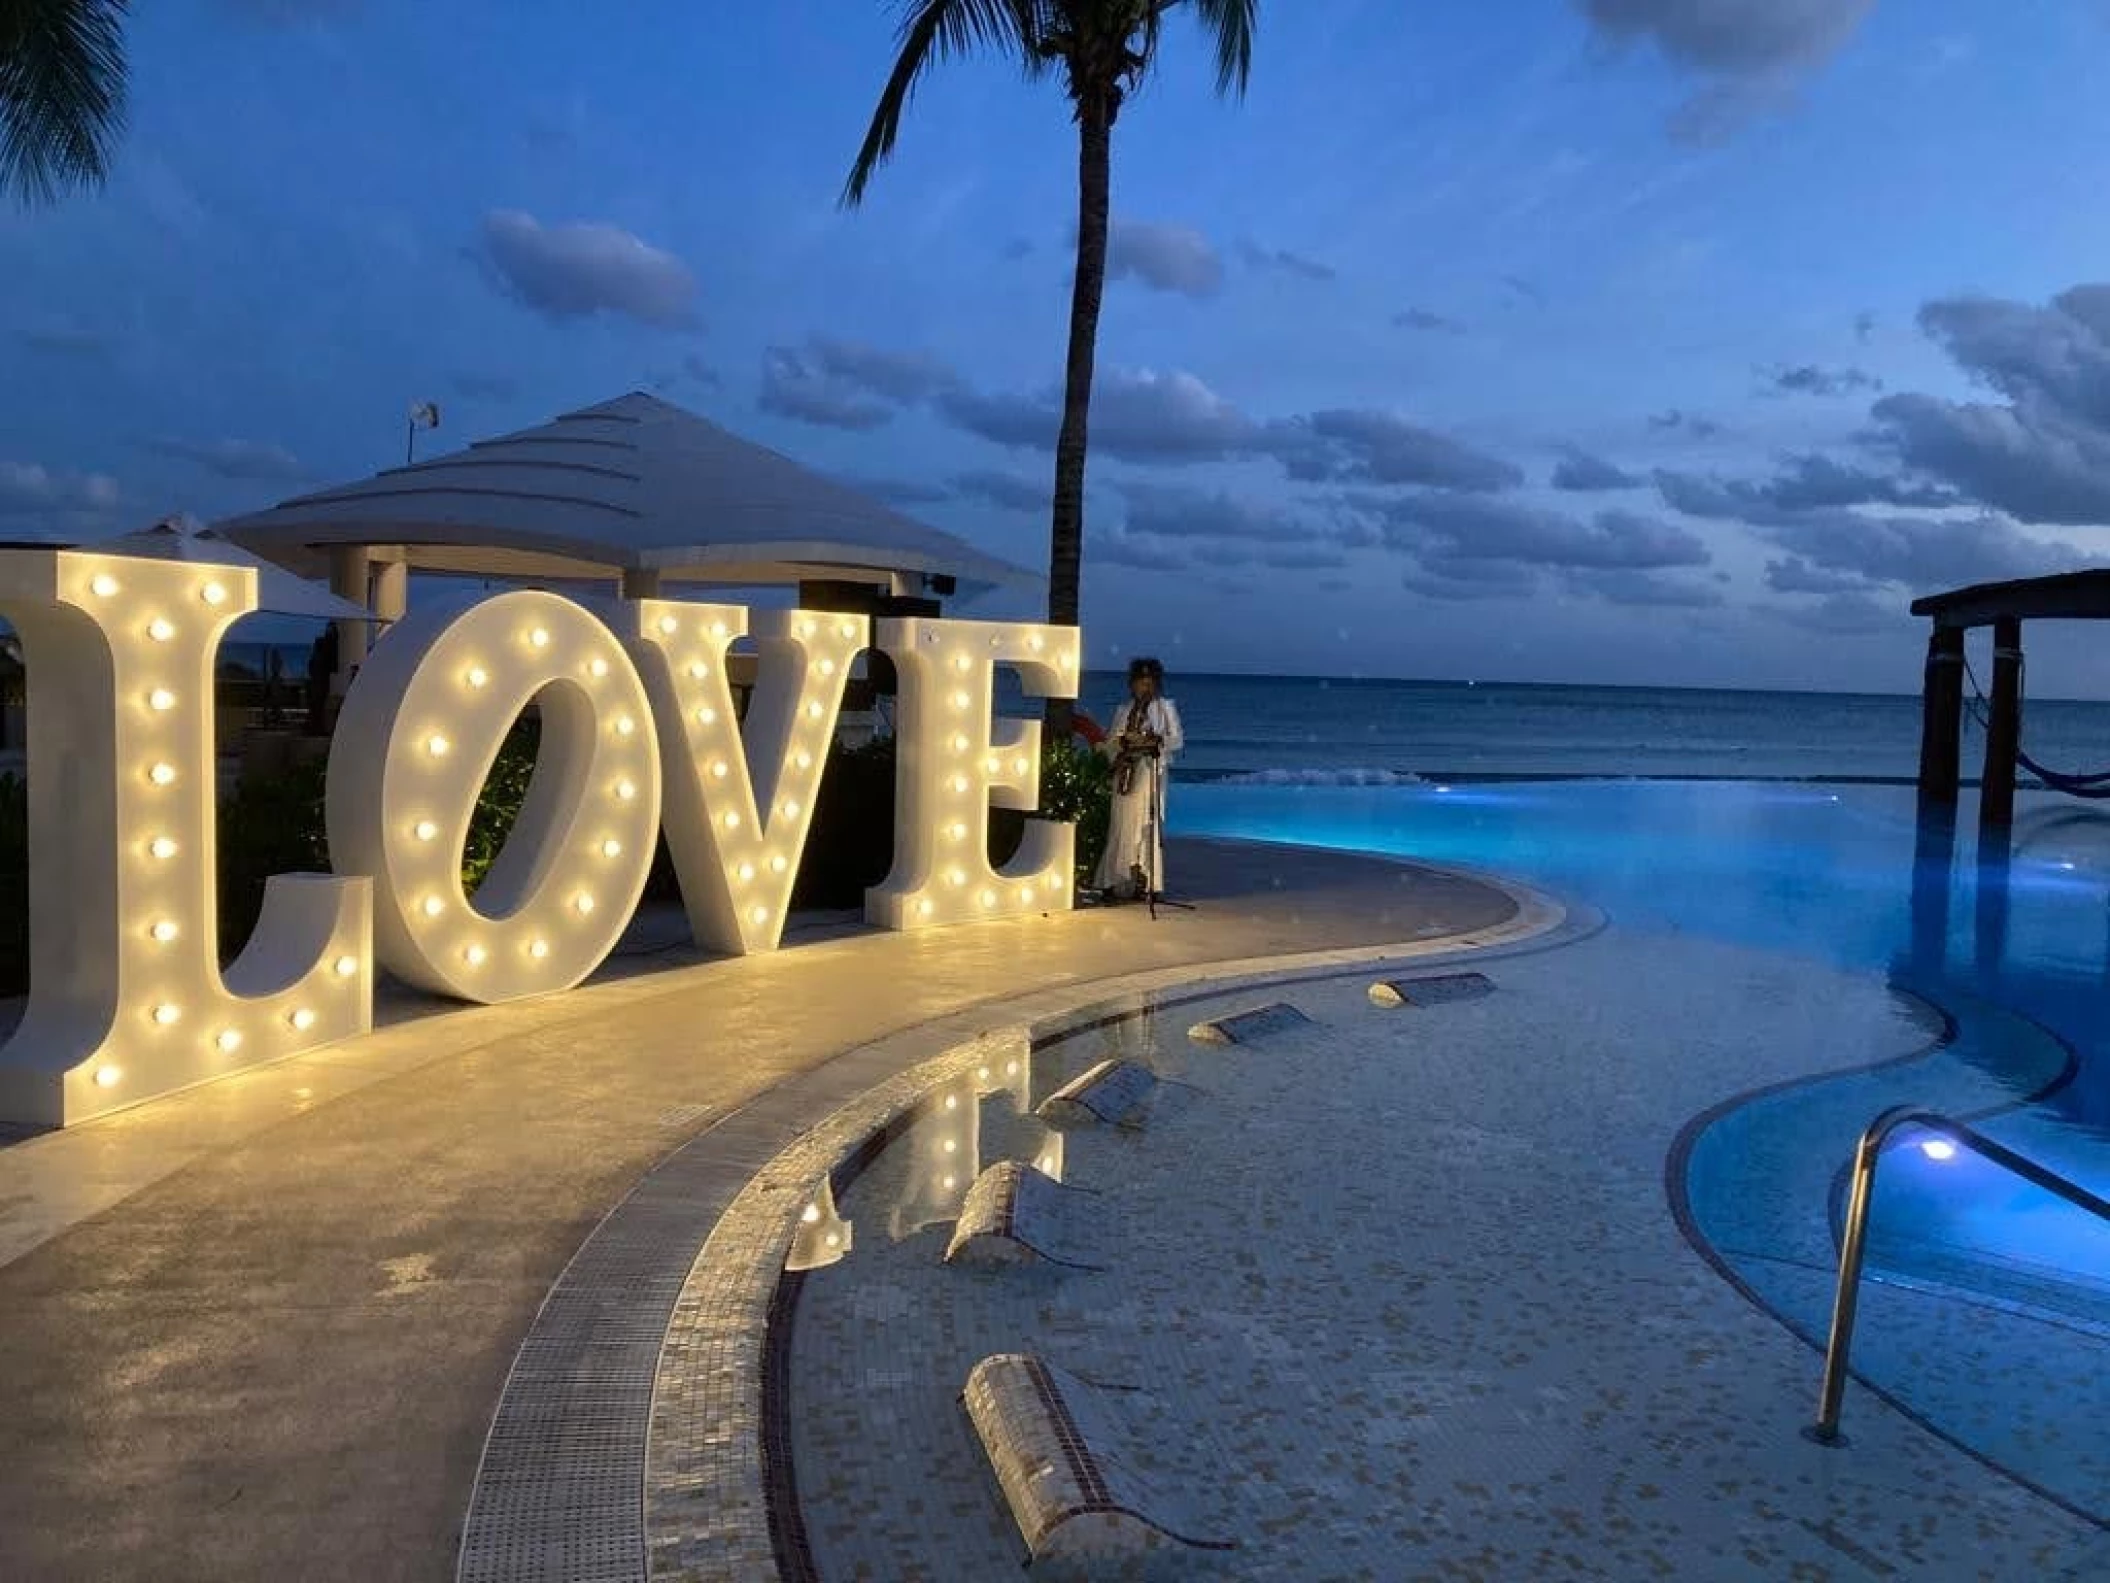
{"left": 1576, "top": 0, "right": 1876, "bottom": 144}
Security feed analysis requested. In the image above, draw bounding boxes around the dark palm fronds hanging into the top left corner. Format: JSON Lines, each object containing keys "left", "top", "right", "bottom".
{"left": 0, "top": 0, "right": 131, "bottom": 205}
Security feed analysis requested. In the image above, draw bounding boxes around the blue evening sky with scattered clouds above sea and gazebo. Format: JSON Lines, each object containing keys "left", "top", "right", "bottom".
{"left": 0, "top": 0, "right": 2110, "bottom": 697}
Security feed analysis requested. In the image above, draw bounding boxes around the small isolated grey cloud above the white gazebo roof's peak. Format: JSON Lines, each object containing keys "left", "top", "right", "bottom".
{"left": 477, "top": 209, "right": 698, "bottom": 329}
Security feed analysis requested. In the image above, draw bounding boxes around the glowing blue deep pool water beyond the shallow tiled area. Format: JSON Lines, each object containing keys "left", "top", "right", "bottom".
{"left": 1169, "top": 781, "right": 2110, "bottom": 1323}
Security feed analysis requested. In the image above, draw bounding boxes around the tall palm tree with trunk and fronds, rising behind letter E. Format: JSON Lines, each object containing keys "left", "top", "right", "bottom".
{"left": 842, "top": 0, "right": 1260, "bottom": 704}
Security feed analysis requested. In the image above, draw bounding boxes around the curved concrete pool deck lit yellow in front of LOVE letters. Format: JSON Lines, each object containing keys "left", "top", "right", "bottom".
{"left": 0, "top": 842, "right": 1515, "bottom": 1579}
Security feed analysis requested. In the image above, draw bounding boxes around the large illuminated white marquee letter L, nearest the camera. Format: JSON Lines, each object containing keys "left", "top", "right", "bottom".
{"left": 0, "top": 551, "right": 373, "bottom": 1125}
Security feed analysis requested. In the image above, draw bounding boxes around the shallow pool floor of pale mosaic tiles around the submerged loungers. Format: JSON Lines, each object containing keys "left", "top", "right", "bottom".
{"left": 789, "top": 929, "right": 2110, "bottom": 1581}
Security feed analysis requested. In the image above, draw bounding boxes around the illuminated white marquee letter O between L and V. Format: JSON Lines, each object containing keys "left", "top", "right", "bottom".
{"left": 327, "top": 593, "right": 660, "bottom": 1005}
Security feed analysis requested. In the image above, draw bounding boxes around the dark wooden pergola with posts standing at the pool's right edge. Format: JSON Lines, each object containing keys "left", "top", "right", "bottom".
{"left": 1912, "top": 570, "right": 2110, "bottom": 846}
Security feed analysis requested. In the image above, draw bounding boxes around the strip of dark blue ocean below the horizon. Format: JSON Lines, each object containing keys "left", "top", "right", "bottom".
{"left": 1082, "top": 673, "right": 2110, "bottom": 785}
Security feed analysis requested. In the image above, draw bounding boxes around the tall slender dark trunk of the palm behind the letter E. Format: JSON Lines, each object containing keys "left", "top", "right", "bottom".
{"left": 1047, "top": 95, "right": 1114, "bottom": 741}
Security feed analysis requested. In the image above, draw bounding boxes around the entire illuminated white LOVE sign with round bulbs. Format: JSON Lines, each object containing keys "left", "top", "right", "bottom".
{"left": 0, "top": 551, "right": 1078, "bottom": 1125}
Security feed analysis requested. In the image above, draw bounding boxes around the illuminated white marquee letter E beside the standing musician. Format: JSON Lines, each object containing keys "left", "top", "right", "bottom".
{"left": 865, "top": 616, "right": 1078, "bottom": 929}
